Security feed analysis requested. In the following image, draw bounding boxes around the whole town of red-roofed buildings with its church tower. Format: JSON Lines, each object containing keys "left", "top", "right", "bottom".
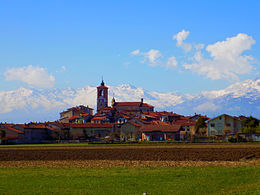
{"left": 0, "top": 80, "right": 260, "bottom": 144}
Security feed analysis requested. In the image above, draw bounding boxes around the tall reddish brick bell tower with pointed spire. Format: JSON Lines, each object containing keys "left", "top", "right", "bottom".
{"left": 97, "top": 79, "right": 108, "bottom": 112}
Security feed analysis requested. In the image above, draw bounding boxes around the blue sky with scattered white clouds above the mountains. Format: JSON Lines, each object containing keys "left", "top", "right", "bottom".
{"left": 0, "top": 0, "right": 260, "bottom": 93}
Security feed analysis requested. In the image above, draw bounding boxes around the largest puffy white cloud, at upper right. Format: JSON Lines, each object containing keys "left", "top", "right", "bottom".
{"left": 183, "top": 33, "right": 255, "bottom": 81}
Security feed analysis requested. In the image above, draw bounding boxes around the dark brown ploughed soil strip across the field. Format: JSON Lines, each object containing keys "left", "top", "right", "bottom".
{"left": 0, "top": 147, "right": 260, "bottom": 161}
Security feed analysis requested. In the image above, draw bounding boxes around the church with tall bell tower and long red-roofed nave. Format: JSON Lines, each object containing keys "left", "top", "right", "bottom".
{"left": 97, "top": 79, "right": 154, "bottom": 113}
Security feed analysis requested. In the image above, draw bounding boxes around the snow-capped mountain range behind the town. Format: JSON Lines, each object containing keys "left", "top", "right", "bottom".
{"left": 0, "top": 78, "right": 260, "bottom": 122}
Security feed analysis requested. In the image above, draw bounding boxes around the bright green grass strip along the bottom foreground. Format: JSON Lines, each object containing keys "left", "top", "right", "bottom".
{"left": 0, "top": 166, "right": 260, "bottom": 194}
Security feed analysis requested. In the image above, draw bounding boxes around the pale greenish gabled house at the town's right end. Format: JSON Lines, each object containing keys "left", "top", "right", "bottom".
{"left": 206, "top": 114, "right": 242, "bottom": 136}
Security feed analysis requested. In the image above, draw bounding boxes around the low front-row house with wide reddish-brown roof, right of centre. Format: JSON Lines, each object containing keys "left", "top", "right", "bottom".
{"left": 139, "top": 124, "right": 181, "bottom": 141}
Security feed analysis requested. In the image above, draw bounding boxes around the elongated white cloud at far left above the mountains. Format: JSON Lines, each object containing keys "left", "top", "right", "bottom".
{"left": 4, "top": 65, "right": 55, "bottom": 88}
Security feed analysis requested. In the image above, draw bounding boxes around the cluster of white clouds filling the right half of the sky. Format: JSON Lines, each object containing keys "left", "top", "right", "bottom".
{"left": 131, "top": 30, "right": 256, "bottom": 82}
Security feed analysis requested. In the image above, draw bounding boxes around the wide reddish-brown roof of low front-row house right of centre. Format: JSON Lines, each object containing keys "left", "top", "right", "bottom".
{"left": 139, "top": 125, "right": 181, "bottom": 132}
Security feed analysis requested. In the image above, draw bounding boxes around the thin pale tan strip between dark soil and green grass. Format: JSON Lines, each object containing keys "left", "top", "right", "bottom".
{"left": 0, "top": 159, "right": 260, "bottom": 168}
